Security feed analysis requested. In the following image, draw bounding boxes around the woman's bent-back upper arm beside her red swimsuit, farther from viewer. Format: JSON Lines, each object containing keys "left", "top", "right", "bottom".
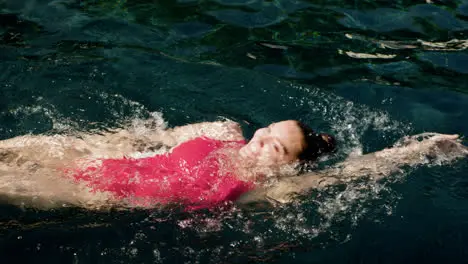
{"left": 157, "top": 121, "right": 244, "bottom": 146}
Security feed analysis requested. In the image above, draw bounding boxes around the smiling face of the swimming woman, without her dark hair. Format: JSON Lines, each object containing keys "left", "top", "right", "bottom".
{"left": 240, "top": 120, "right": 306, "bottom": 166}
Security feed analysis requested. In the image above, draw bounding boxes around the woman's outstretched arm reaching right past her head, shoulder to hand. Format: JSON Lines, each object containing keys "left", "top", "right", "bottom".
{"left": 238, "top": 133, "right": 468, "bottom": 204}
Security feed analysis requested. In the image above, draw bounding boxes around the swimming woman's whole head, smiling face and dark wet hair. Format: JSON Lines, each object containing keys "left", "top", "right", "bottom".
{"left": 240, "top": 120, "right": 335, "bottom": 166}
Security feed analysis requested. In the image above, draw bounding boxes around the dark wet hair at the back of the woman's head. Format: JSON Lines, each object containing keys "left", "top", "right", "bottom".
{"left": 297, "top": 121, "right": 336, "bottom": 162}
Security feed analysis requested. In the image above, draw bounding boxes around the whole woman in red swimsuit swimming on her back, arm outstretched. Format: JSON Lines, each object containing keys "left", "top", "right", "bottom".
{"left": 0, "top": 120, "right": 468, "bottom": 209}
